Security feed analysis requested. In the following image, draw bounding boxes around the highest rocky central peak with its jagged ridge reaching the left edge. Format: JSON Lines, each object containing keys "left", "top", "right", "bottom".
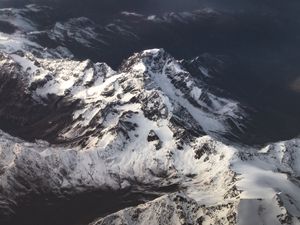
{"left": 1, "top": 49, "right": 246, "bottom": 146}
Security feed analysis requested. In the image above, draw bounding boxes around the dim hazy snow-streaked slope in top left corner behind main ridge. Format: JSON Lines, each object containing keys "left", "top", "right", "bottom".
{"left": 0, "top": 5, "right": 73, "bottom": 58}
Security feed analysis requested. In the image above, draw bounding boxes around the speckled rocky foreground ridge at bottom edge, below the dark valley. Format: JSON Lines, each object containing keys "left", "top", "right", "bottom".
{"left": 92, "top": 194, "right": 236, "bottom": 225}
